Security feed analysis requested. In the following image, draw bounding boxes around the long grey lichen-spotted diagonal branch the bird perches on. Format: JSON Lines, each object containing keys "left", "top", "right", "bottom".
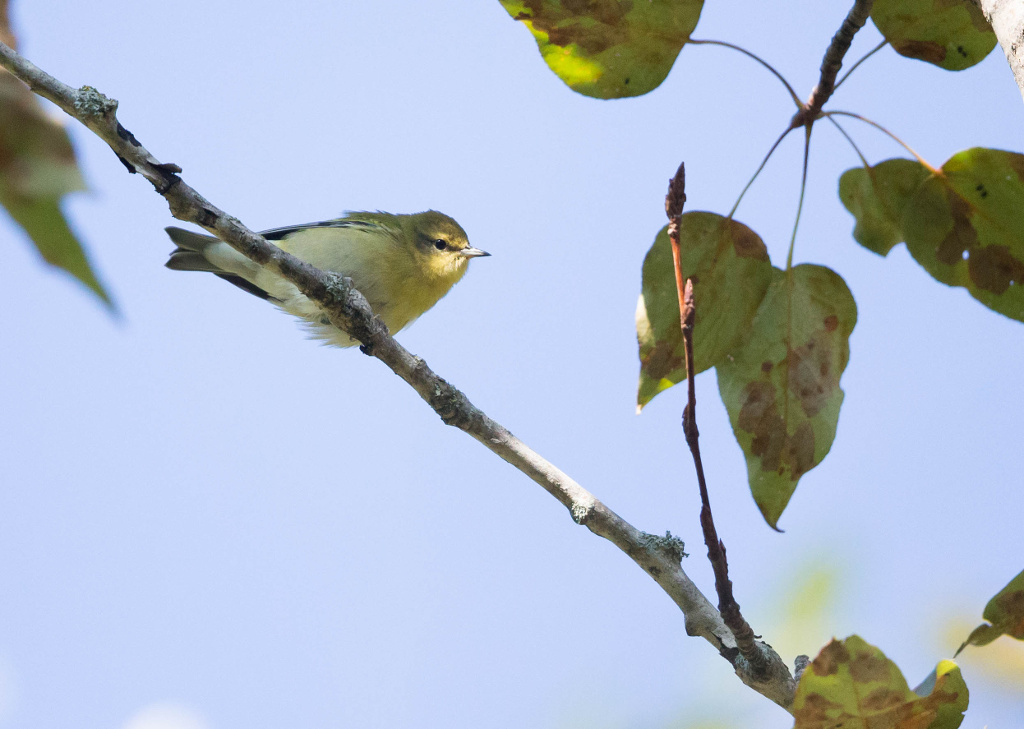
{"left": 0, "top": 43, "right": 796, "bottom": 709}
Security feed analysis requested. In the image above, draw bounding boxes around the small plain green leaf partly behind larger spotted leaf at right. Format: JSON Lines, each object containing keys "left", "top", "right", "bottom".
{"left": 839, "top": 159, "right": 929, "bottom": 256}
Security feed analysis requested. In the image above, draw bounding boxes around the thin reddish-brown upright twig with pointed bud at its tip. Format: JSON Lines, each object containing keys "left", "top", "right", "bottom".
{"left": 665, "top": 164, "right": 772, "bottom": 676}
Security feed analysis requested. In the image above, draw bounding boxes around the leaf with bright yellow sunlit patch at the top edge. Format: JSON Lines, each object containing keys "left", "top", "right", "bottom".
{"left": 501, "top": 0, "right": 703, "bottom": 98}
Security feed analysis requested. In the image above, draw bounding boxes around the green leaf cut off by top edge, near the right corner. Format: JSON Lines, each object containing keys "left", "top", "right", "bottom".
{"left": 871, "top": 0, "right": 995, "bottom": 71}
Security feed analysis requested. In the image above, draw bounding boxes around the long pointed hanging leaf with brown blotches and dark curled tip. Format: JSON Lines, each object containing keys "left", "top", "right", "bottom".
{"left": 718, "top": 264, "right": 857, "bottom": 527}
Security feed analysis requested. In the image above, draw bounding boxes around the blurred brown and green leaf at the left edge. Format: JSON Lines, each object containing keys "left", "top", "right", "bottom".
{"left": 0, "top": 0, "right": 111, "bottom": 305}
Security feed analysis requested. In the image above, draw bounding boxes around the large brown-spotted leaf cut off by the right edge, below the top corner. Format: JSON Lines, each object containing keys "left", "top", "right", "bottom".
{"left": 901, "top": 147, "right": 1024, "bottom": 321}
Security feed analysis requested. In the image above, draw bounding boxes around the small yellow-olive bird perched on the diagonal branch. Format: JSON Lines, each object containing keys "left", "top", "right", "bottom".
{"left": 167, "top": 210, "right": 490, "bottom": 347}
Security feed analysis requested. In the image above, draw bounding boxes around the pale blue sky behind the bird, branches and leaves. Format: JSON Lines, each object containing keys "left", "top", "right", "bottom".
{"left": 0, "top": 0, "right": 1024, "bottom": 729}
